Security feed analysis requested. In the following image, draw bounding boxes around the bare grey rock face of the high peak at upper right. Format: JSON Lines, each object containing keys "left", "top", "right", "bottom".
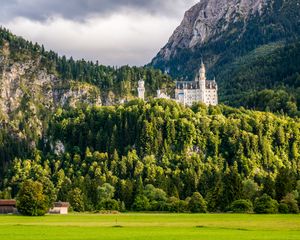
{"left": 158, "top": 0, "right": 269, "bottom": 60}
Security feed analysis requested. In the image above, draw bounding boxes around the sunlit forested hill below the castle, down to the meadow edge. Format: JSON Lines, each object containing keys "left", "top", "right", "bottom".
{"left": 2, "top": 100, "right": 300, "bottom": 212}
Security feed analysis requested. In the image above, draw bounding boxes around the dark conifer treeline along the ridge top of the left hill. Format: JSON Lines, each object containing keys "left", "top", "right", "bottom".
{"left": 0, "top": 28, "right": 173, "bottom": 98}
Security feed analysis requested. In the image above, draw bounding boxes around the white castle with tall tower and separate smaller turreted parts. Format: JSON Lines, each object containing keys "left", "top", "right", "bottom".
{"left": 138, "top": 62, "right": 218, "bottom": 106}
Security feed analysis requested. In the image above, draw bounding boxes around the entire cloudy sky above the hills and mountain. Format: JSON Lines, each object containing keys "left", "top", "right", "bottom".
{"left": 0, "top": 0, "right": 199, "bottom": 66}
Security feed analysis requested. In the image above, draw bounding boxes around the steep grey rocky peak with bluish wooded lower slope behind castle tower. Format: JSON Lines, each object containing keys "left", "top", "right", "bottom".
{"left": 151, "top": 0, "right": 300, "bottom": 75}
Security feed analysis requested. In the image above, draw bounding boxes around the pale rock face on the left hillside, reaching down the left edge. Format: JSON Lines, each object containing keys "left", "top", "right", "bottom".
{"left": 0, "top": 44, "right": 102, "bottom": 139}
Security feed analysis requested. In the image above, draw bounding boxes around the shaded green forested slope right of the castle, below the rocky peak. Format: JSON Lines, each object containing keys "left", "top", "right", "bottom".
{"left": 219, "top": 41, "right": 300, "bottom": 116}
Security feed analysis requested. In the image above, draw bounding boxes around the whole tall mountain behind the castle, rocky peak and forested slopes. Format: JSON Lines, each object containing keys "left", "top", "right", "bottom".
{"left": 151, "top": 0, "right": 300, "bottom": 115}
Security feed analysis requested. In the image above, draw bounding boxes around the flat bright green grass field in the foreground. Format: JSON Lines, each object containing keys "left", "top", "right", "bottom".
{"left": 0, "top": 214, "right": 300, "bottom": 240}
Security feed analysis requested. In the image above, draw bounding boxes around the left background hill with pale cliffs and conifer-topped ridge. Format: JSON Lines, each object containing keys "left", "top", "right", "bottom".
{"left": 0, "top": 28, "right": 173, "bottom": 175}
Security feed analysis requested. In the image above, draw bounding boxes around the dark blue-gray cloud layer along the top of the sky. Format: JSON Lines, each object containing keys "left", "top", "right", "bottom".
{"left": 0, "top": 0, "right": 198, "bottom": 22}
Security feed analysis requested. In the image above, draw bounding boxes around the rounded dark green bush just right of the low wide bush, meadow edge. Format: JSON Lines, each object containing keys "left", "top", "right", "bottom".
{"left": 254, "top": 194, "right": 278, "bottom": 214}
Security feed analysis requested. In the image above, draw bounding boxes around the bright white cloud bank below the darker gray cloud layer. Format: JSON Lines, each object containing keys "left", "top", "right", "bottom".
{"left": 8, "top": 13, "right": 178, "bottom": 65}
